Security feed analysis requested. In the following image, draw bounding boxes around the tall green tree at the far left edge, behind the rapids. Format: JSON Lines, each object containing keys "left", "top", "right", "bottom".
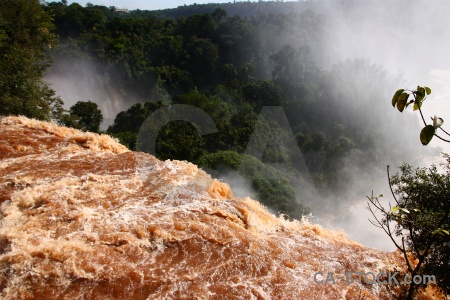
{"left": 0, "top": 0, "right": 62, "bottom": 120}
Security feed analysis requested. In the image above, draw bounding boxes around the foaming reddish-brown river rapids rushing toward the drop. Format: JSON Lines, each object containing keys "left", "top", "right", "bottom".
{"left": 0, "top": 117, "right": 442, "bottom": 299}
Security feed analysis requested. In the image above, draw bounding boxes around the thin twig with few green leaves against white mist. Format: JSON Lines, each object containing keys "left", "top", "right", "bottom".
{"left": 392, "top": 86, "right": 450, "bottom": 145}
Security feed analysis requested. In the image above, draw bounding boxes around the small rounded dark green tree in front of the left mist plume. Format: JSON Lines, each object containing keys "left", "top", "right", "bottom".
{"left": 63, "top": 101, "right": 103, "bottom": 132}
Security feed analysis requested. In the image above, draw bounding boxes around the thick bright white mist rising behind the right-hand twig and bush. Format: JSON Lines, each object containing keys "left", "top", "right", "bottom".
{"left": 258, "top": 1, "right": 450, "bottom": 251}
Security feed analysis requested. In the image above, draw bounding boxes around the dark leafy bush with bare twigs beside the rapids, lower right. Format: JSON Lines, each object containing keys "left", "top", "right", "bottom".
{"left": 367, "top": 161, "right": 450, "bottom": 299}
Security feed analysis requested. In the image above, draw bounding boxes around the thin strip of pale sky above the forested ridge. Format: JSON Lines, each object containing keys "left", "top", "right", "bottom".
{"left": 67, "top": 0, "right": 268, "bottom": 10}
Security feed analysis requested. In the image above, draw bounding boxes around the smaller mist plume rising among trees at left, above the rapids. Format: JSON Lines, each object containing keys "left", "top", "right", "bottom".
{"left": 44, "top": 42, "right": 160, "bottom": 131}
